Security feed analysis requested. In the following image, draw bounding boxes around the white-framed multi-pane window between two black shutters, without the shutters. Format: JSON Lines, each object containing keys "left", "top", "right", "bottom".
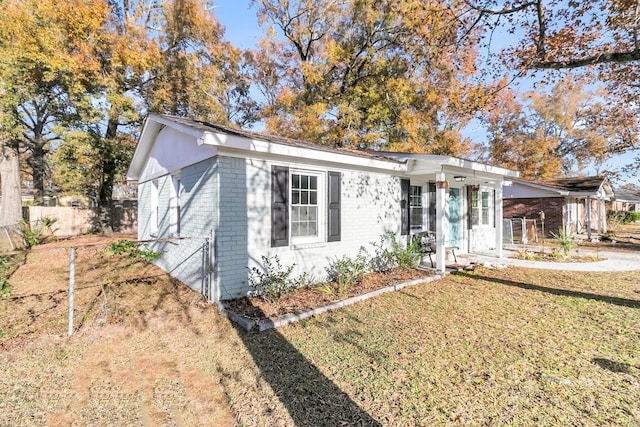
{"left": 291, "top": 173, "right": 320, "bottom": 239}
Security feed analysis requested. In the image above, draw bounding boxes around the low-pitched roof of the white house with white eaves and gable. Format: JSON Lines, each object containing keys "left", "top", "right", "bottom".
{"left": 127, "top": 114, "right": 518, "bottom": 181}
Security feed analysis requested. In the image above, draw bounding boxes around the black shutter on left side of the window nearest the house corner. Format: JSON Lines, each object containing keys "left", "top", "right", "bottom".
{"left": 271, "top": 166, "right": 289, "bottom": 247}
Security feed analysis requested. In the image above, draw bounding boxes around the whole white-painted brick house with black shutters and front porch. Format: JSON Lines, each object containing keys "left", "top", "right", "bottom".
{"left": 128, "top": 115, "right": 518, "bottom": 301}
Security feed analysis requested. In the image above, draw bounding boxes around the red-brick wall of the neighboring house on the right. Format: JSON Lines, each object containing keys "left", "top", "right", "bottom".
{"left": 502, "top": 197, "right": 564, "bottom": 237}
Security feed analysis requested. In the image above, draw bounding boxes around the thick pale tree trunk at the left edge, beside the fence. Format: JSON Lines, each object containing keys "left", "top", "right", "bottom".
{"left": 0, "top": 143, "right": 22, "bottom": 225}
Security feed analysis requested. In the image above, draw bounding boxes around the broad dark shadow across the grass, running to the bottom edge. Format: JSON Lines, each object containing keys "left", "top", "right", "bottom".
{"left": 236, "top": 310, "right": 381, "bottom": 426}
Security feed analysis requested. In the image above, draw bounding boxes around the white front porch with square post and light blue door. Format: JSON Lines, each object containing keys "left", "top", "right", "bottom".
{"left": 385, "top": 153, "right": 518, "bottom": 273}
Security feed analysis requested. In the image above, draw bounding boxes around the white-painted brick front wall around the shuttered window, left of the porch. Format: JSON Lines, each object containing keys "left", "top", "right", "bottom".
{"left": 216, "top": 157, "right": 401, "bottom": 299}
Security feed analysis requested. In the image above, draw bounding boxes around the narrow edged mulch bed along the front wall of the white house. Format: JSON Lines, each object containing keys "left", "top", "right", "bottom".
{"left": 223, "top": 268, "right": 435, "bottom": 320}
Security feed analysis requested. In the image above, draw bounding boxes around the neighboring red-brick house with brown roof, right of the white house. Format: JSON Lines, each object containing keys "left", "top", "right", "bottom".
{"left": 503, "top": 176, "right": 613, "bottom": 239}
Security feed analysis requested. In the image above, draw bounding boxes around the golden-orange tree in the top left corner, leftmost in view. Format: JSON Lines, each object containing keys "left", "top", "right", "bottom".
{"left": 0, "top": 0, "right": 106, "bottom": 204}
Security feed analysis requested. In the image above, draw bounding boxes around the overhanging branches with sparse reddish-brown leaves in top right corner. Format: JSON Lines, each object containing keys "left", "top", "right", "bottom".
{"left": 466, "top": 0, "right": 640, "bottom": 171}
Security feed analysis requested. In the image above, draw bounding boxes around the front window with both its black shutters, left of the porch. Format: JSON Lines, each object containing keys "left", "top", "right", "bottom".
{"left": 271, "top": 166, "right": 341, "bottom": 247}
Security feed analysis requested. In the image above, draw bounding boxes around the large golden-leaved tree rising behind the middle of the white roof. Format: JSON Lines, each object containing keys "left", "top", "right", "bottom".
{"left": 254, "top": 0, "right": 490, "bottom": 155}
